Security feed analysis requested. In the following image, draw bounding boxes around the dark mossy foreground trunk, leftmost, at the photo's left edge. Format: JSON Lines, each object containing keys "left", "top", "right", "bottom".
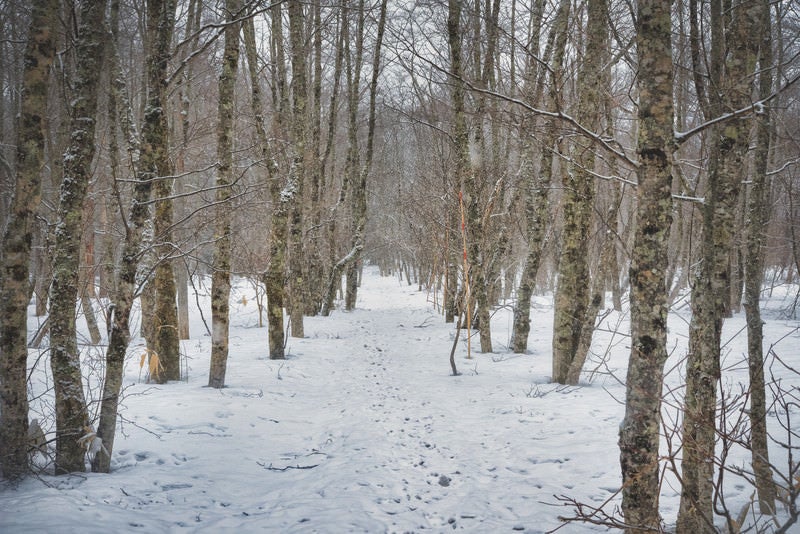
{"left": 0, "top": 0, "right": 59, "bottom": 479}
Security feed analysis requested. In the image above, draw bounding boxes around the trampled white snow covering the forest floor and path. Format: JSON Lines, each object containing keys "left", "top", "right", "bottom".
{"left": 0, "top": 268, "right": 800, "bottom": 533}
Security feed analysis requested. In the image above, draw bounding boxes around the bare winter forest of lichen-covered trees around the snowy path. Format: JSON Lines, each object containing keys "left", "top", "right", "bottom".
{"left": 0, "top": 0, "right": 800, "bottom": 533}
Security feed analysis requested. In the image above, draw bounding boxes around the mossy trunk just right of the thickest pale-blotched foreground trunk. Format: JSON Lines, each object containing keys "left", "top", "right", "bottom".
{"left": 678, "top": 0, "right": 757, "bottom": 534}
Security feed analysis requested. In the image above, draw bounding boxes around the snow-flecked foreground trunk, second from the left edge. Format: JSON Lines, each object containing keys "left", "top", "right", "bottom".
{"left": 50, "top": 1, "right": 105, "bottom": 474}
